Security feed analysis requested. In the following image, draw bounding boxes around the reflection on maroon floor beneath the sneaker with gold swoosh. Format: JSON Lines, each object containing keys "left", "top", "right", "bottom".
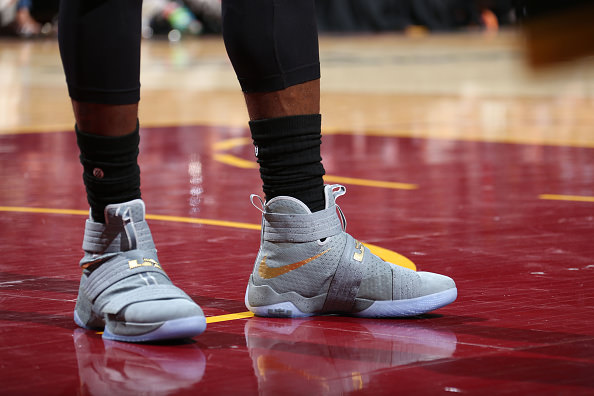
{"left": 244, "top": 318, "right": 457, "bottom": 395}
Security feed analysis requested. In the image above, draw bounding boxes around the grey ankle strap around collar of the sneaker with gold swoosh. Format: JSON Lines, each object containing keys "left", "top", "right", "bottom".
{"left": 262, "top": 205, "right": 343, "bottom": 242}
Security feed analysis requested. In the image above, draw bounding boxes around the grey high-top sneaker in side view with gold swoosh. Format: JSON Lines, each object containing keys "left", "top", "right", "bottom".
{"left": 245, "top": 185, "right": 457, "bottom": 318}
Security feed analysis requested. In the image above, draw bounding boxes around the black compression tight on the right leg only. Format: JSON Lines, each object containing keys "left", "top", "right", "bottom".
{"left": 223, "top": 0, "right": 320, "bottom": 93}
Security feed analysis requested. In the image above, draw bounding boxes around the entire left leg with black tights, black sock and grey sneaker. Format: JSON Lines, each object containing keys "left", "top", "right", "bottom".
{"left": 59, "top": 0, "right": 206, "bottom": 342}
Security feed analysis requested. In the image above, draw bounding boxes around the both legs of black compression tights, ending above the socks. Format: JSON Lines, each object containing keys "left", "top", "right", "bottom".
{"left": 59, "top": 0, "right": 320, "bottom": 105}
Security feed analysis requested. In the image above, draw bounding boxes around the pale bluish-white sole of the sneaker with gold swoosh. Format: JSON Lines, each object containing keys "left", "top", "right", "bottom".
{"left": 245, "top": 286, "right": 458, "bottom": 318}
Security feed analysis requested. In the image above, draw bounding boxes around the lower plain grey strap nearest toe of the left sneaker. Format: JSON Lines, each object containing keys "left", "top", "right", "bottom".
{"left": 95, "top": 284, "right": 193, "bottom": 315}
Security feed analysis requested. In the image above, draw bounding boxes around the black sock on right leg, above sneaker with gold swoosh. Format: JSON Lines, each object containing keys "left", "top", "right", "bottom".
{"left": 250, "top": 114, "right": 325, "bottom": 212}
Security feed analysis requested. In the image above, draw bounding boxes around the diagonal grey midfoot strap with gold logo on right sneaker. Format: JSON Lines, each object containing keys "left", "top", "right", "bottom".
{"left": 322, "top": 234, "right": 370, "bottom": 313}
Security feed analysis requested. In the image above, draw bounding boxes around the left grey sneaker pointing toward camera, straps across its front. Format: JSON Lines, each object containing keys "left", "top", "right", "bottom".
{"left": 74, "top": 199, "right": 206, "bottom": 342}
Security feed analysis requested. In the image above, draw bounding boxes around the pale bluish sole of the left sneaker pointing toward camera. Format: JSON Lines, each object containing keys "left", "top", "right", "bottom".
{"left": 74, "top": 311, "right": 206, "bottom": 342}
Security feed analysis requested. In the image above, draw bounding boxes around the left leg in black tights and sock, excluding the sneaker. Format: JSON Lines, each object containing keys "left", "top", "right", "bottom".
{"left": 58, "top": 0, "right": 142, "bottom": 222}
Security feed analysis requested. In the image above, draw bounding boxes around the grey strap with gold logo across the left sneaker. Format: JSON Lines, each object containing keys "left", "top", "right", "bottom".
{"left": 81, "top": 250, "right": 169, "bottom": 301}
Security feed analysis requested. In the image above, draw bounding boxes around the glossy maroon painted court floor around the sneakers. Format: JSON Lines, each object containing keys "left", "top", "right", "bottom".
{"left": 0, "top": 127, "right": 594, "bottom": 395}
